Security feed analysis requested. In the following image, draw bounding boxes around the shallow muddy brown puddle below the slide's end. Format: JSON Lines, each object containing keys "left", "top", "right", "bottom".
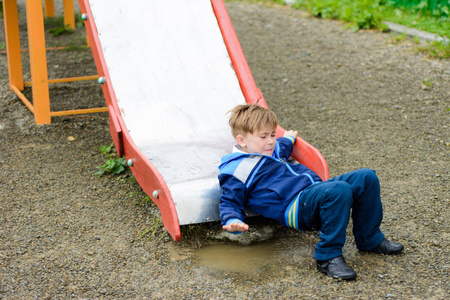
{"left": 194, "top": 235, "right": 315, "bottom": 275}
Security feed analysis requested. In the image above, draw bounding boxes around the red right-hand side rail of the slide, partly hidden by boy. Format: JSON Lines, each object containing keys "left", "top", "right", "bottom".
{"left": 211, "top": 0, "right": 329, "bottom": 180}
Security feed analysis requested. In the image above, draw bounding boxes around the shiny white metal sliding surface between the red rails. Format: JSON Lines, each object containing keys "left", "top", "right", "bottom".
{"left": 89, "top": 0, "right": 245, "bottom": 225}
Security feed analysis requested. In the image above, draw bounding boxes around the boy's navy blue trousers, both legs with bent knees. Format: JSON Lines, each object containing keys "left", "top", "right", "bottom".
{"left": 299, "top": 169, "right": 384, "bottom": 260}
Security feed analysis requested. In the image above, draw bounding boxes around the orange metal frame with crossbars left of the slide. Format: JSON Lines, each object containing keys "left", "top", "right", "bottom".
{"left": 3, "top": 0, "right": 108, "bottom": 124}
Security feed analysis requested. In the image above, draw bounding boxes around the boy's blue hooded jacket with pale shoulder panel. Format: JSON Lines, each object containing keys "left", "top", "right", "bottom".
{"left": 219, "top": 138, "right": 322, "bottom": 225}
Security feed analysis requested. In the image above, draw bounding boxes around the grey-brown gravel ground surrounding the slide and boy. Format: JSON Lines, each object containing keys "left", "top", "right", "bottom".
{"left": 0, "top": 2, "right": 450, "bottom": 299}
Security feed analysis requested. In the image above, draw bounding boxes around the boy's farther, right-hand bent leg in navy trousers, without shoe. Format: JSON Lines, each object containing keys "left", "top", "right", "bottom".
{"left": 330, "top": 169, "right": 384, "bottom": 250}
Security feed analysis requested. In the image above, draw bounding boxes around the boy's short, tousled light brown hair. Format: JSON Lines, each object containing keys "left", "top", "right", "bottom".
{"left": 229, "top": 104, "right": 278, "bottom": 137}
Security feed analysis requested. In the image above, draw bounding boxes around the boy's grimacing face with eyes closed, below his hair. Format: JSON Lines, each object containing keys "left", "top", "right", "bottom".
{"left": 236, "top": 129, "right": 276, "bottom": 156}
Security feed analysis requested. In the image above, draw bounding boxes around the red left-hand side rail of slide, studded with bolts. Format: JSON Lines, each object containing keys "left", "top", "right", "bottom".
{"left": 78, "top": 0, "right": 181, "bottom": 241}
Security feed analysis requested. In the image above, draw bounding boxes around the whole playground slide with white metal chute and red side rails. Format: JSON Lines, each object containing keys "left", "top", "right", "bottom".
{"left": 79, "top": 0, "right": 328, "bottom": 240}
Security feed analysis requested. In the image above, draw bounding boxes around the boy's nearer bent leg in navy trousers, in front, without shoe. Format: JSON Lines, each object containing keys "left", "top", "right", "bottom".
{"left": 298, "top": 181, "right": 353, "bottom": 261}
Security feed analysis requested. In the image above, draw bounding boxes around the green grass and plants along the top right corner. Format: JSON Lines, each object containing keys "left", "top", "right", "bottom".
{"left": 293, "top": 0, "right": 450, "bottom": 58}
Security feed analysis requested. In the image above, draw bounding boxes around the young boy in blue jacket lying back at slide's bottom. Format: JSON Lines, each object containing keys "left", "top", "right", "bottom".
{"left": 219, "top": 105, "right": 403, "bottom": 280}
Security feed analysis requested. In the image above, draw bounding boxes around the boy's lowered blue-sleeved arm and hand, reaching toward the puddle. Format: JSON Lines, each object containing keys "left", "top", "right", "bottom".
{"left": 219, "top": 174, "right": 248, "bottom": 233}
